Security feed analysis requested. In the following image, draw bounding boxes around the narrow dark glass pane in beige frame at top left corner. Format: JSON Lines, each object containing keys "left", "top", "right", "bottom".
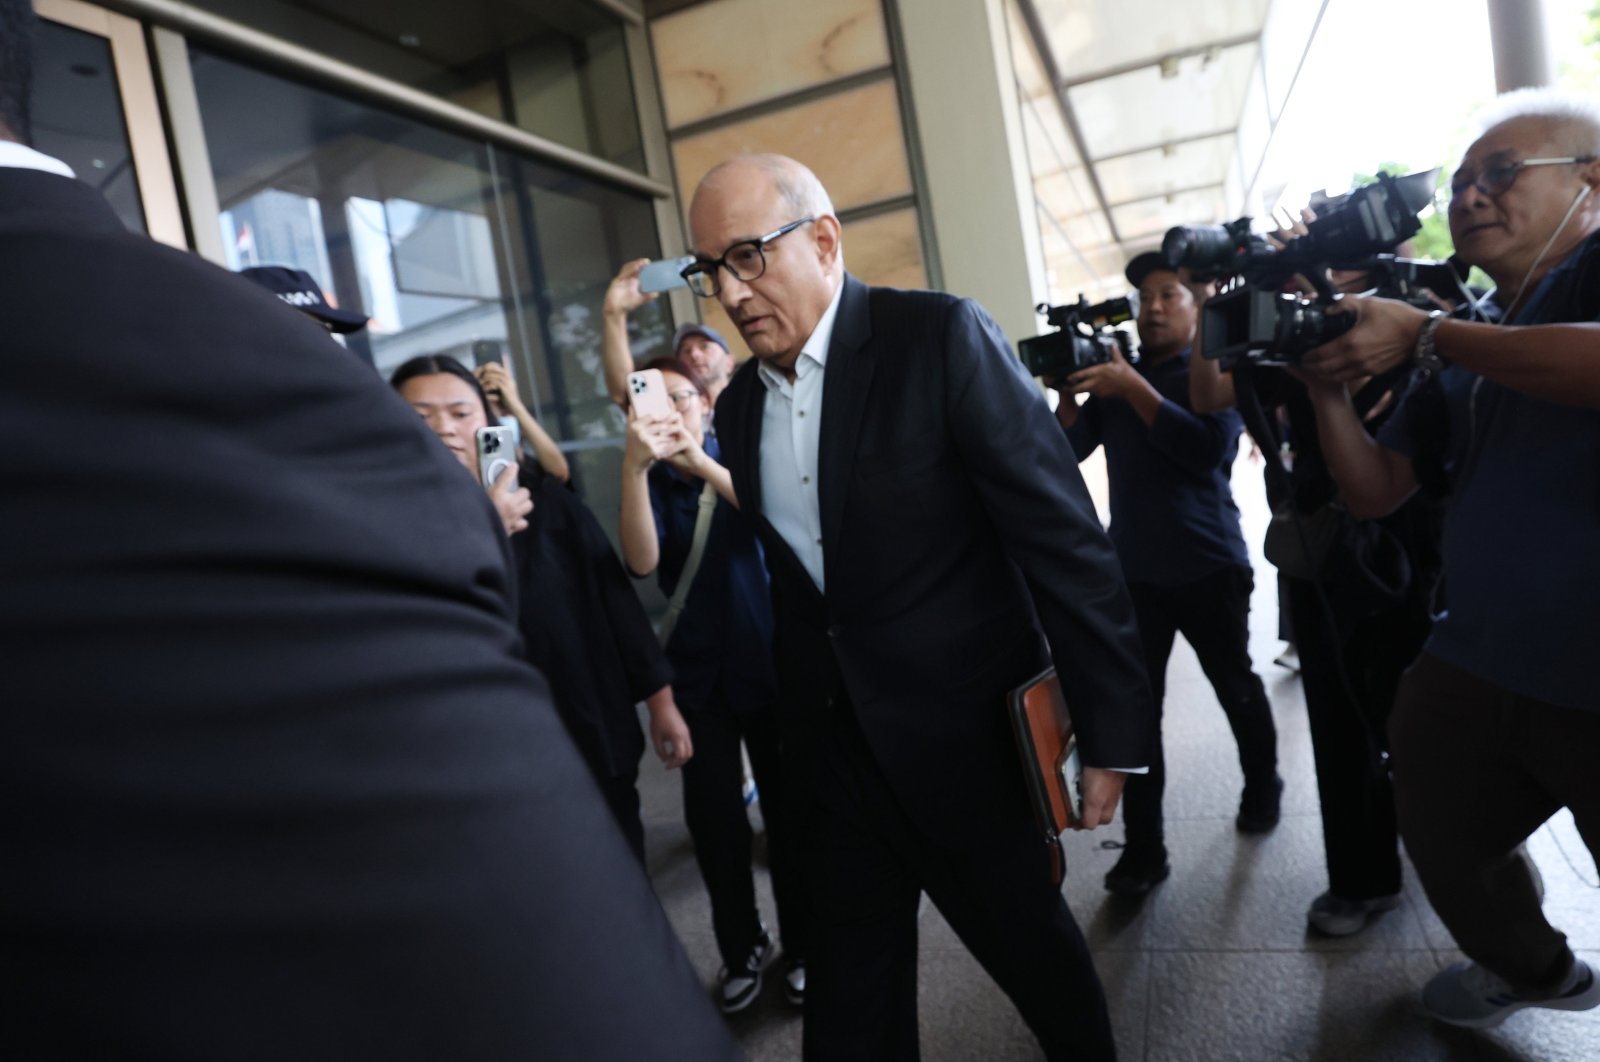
{"left": 34, "top": 19, "right": 146, "bottom": 232}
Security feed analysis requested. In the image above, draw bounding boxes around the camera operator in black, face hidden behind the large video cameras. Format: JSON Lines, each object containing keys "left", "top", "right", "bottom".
{"left": 1189, "top": 235, "right": 1438, "bottom": 936}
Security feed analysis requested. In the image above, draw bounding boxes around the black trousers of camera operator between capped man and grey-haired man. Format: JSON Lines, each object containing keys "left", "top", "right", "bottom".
{"left": 1285, "top": 579, "right": 1429, "bottom": 900}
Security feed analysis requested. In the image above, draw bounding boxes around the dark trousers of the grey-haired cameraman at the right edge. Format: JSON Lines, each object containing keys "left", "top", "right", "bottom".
{"left": 1389, "top": 653, "right": 1600, "bottom": 995}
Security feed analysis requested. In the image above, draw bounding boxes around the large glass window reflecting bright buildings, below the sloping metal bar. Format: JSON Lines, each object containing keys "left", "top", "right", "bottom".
{"left": 190, "top": 46, "right": 672, "bottom": 521}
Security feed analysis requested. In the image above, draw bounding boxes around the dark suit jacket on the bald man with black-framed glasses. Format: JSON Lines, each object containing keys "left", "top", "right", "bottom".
{"left": 717, "top": 277, "right": 1157, "bottom": 838}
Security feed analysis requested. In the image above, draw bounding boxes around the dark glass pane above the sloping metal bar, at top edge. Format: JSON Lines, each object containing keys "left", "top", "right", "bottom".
{"left": 183, "top": 0, "right": 645, "bottom": 173}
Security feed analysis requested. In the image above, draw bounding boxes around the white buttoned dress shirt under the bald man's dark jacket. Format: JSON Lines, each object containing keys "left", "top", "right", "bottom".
{"left": 757, "top": 280, "right": 845, "bottom": 590}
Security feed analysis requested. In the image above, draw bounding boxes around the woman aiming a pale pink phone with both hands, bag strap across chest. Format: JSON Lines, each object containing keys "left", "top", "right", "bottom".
{"left": 622, "top": 358, "right": 806, "bottom": 1012}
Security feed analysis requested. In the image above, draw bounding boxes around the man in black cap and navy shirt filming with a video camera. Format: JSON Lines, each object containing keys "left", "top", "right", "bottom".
{"left": 1051, "top": 251, "right": 1283, "bottom": 896}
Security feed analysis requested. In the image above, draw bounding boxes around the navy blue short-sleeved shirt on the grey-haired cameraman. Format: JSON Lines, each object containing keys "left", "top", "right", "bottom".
{"left": 1378, "top": 234, "right": 1600, "bottom": 710}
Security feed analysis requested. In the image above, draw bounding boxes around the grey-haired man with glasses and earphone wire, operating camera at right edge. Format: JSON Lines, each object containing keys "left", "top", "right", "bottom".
{"left": 1304, "top": 90, "right": 1600, "bottom": 1027}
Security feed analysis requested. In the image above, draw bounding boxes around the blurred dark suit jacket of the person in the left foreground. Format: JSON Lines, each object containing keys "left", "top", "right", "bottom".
{"left": 0, "top": 170, "right": 734, "bottom": 1060}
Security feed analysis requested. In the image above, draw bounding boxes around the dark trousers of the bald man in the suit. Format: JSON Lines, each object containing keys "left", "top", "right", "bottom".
{"left": 803, "top": 704, "right": 1115, "bottom": 1062}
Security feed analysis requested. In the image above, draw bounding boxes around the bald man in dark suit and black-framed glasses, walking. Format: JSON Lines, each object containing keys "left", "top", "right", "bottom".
{"left": 686, "top": 155, "right": 1155, "bottom": 1062}
